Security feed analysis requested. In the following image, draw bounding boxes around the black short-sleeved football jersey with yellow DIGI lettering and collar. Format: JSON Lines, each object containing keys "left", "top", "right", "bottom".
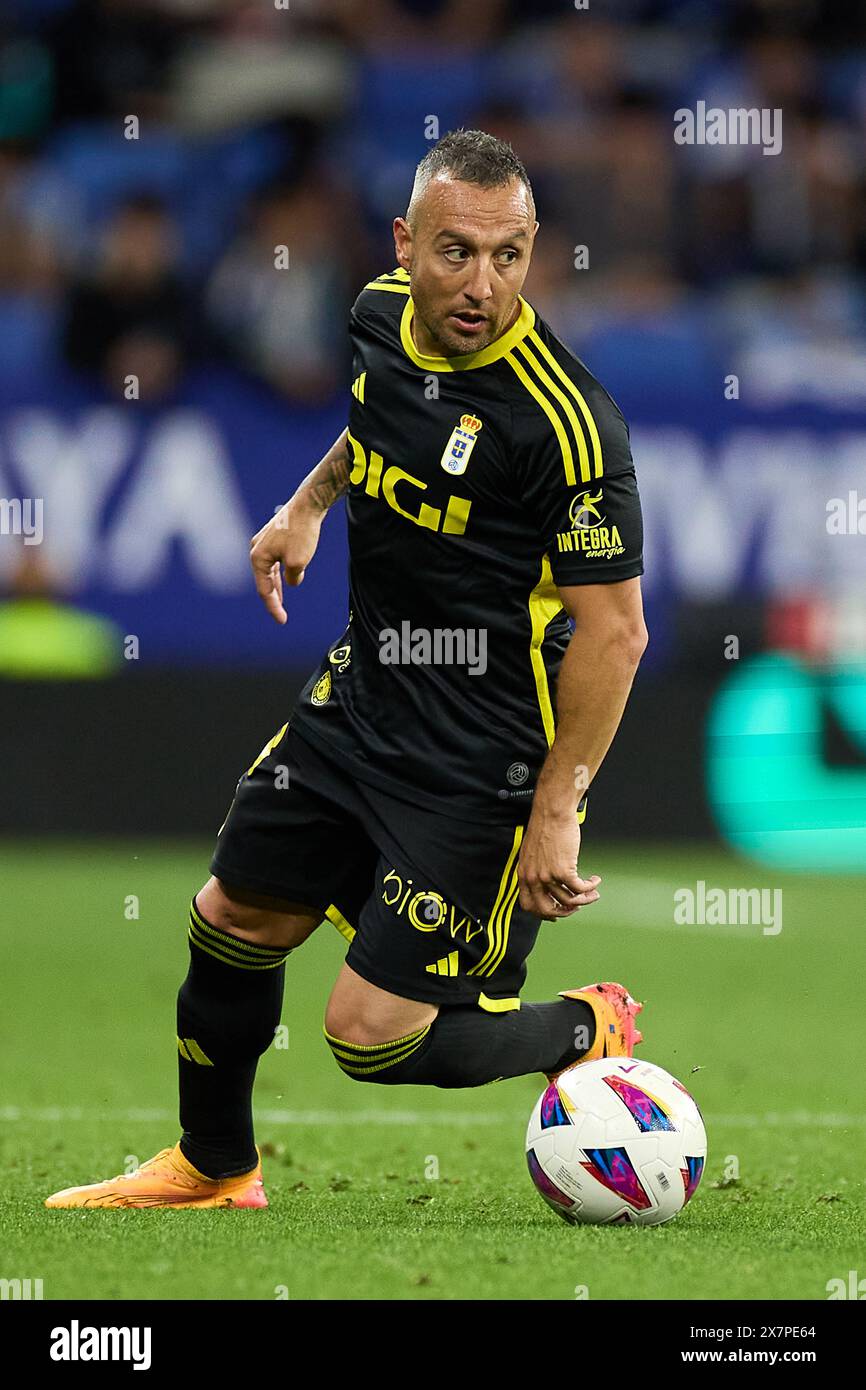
{"left": 292, "top": 270, "right": 644, "bottom": 821}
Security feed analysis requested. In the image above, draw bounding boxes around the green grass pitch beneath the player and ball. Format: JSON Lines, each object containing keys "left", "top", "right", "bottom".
{"left": 0, "top": 837, "right": 866, "bottom": 1300}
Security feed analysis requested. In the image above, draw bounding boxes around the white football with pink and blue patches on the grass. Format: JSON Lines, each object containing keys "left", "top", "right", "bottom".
{"left": 527, "top": 1056, "right": 706, "bottom": 1226}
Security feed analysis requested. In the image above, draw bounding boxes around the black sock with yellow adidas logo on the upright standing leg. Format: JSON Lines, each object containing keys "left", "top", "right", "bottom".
{"left": 178, "top": 898, "right": 289, "bottom": 1177}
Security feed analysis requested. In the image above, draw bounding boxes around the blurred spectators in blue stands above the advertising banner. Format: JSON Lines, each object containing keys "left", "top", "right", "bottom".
{"left": 0, "top": 0, "right": 866, "bottom": 404}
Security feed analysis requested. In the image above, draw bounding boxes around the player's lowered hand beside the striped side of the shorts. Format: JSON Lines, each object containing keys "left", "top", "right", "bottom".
{"left": 517, "top": 801, "right": 602, "bottom": 922}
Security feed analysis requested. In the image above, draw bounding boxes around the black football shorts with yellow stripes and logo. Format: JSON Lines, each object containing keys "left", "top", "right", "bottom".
{"left": 210, "top": 726, "right": 541, "bottom": 1012}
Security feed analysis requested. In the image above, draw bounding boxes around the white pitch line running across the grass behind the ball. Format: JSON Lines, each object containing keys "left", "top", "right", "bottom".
{"left": 0, "top": 1105, "right": 866, "bottom": 1129}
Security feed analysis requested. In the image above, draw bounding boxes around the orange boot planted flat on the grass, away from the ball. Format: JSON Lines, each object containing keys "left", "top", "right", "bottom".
{"left": 44, "top": 1144, "right": 268, "bottom": 1209}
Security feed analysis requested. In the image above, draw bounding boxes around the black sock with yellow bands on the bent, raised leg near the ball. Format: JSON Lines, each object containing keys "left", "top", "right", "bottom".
{"left": 325, "top": 999, "right": 595, "bottom": 1087}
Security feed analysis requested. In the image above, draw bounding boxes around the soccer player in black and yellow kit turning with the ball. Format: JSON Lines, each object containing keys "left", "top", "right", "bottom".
{"left": 47, "top": 131, "right": 646, "bottom": 1208}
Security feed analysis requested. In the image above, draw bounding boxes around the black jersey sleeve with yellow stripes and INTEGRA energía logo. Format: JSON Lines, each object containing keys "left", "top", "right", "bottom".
{"left": 516, "top": 389, "right": 644, "bottom": 585}
